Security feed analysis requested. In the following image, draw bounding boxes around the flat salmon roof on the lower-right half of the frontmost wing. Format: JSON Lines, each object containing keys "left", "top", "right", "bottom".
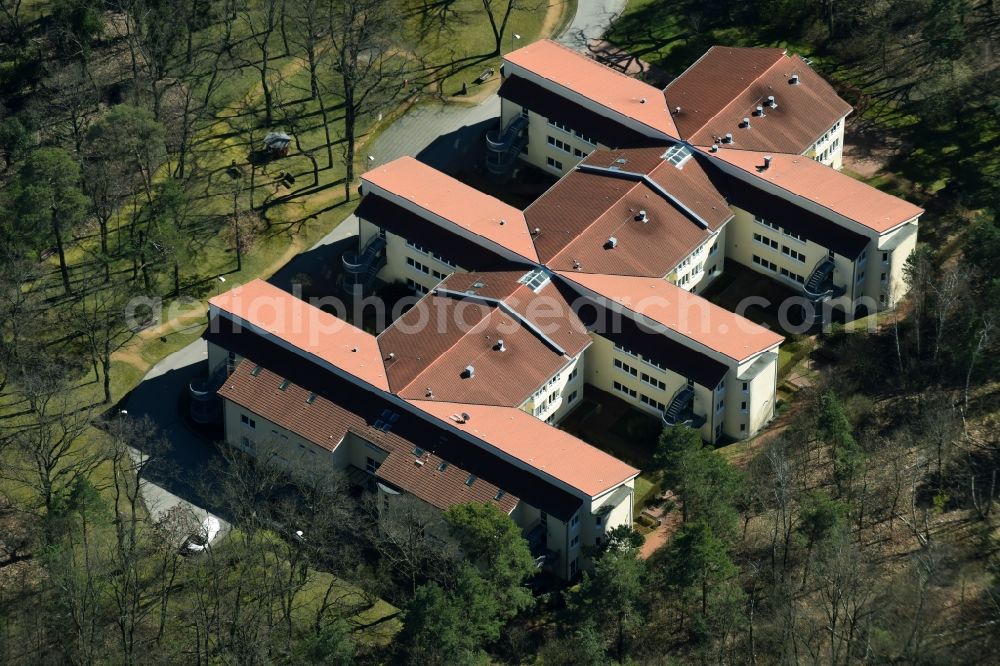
{"left": 411, "top": 400, "right": 639, "bottom": 497}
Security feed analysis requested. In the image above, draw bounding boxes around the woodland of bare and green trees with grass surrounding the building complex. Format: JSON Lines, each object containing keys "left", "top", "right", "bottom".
{"left": 0, "top": 0, "right": 1000, "bottom": 666}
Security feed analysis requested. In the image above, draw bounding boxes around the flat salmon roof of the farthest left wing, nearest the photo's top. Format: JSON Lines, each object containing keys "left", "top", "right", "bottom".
{"left": 504, "top": 39, "right": 677, "bottom": 136}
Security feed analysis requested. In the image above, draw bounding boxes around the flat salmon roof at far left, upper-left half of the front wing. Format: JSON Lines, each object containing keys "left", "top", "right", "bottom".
{"left": 209, "top": 280, "right": 389, "bottom": 391}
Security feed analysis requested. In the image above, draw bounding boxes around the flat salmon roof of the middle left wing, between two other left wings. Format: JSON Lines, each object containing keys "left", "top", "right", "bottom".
{"left": 361, "top": 157, "right": 538, "bottom": 262}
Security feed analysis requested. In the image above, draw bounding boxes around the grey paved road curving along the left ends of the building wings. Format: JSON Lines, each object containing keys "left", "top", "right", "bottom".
{"left": 126, "top": 0, "right": 626, "bottom": 537}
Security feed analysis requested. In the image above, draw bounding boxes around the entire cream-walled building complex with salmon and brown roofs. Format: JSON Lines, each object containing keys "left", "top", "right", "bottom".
{"left": 209, "top": 41, "right": 921, "bottom": 577}
